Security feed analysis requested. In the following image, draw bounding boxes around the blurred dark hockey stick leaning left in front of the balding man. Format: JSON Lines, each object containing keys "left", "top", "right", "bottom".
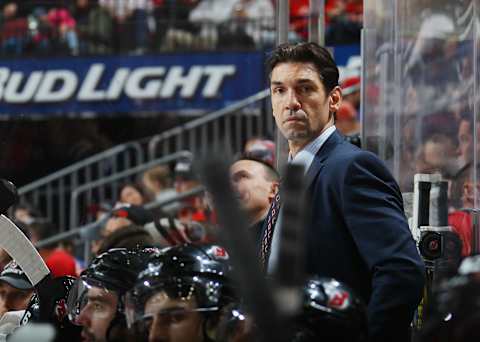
{"left": 201, "top": 155, "right": 286, "bottom": 342}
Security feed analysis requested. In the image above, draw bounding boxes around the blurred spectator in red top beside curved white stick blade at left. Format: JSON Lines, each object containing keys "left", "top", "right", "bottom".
{"left": 29, "top": 220, "right": 77, "bottom": 277}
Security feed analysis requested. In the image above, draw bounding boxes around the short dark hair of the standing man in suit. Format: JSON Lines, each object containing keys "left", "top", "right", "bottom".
{"left": 266, "top": 42, "right": 339, "bottom": 93}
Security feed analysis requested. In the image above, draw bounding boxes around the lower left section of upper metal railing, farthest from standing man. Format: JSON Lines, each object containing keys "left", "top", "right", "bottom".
{"left": 18, "top": 142, "right": 144, "bottom": 231}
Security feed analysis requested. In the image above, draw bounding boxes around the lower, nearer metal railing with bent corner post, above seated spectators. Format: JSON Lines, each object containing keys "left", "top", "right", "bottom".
{"left": 70, "top": 151, "right": 192, "bottom": 227}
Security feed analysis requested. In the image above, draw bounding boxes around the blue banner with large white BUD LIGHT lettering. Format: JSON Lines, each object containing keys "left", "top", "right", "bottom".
{"left": 0, "top": 52, "right": 265, "bottom": 116}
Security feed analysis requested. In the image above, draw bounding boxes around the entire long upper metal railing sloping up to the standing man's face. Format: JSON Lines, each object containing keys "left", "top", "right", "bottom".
{"left": 19, "top": 89, "right": 274, "bottom": 231}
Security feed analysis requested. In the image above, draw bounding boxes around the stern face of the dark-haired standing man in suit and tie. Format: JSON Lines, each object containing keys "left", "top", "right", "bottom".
{"left": 270, "top": 63, "right": 342, "bottom": 154}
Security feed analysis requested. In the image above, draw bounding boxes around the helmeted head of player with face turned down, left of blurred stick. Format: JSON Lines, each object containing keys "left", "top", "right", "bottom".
{"left": 127, "top": 244, "right": 234, "bottom": 342}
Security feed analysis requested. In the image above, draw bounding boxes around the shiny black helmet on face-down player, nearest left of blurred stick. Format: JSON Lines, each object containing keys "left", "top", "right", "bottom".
{"left": 126, "top": 244, "right": 235, "bottom": 336}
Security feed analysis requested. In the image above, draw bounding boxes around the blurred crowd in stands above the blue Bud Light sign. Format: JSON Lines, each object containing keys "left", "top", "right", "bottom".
{"left": 0, "top": 0, "right": 363, "bottom": 56}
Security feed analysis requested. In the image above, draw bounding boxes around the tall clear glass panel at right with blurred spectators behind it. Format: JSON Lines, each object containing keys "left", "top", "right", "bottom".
{"left": 362, "top": 0, "right": 480, "bottom": 255}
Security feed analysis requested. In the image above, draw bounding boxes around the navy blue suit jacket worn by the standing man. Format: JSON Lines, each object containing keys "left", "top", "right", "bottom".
{"left": 306, "top": 131, "right": 424, "bottom": 342}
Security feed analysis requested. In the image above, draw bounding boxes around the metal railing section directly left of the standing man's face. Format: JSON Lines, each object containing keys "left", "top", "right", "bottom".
{"left": 148, "top": 89, "right": 274, "bottom": 160}
